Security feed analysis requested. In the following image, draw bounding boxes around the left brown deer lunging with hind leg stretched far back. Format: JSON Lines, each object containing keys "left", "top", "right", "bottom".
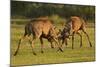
{"left": 14, "top": 18, "right": 63, "bottom": 56}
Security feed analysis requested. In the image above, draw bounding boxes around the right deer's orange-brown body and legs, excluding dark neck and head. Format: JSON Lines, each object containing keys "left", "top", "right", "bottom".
{"left": 70, "top": 16, "right": 92, "bottom": 49}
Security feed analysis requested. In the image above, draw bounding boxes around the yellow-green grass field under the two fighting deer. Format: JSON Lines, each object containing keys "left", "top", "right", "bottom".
{"left": 11, "top": 24, "right": 95, "bottom": 66}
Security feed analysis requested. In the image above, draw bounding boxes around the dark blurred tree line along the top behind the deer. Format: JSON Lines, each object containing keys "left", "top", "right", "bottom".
{"left": 11, "top": 1, "right": 95, "bottom": 20}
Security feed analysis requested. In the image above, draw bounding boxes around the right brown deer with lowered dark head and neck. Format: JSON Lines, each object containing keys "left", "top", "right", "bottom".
{"left": 59, "top": 16, "right": 92, "bottom": 49}
